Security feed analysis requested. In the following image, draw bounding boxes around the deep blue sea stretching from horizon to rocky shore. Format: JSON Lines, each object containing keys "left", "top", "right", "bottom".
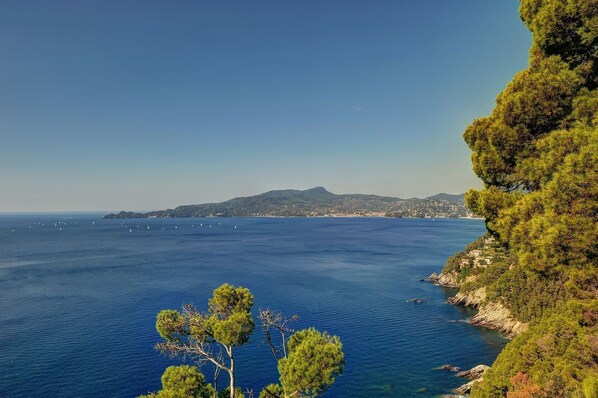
{"left": 0, "top": 214, "right": 505, "bottom": 398}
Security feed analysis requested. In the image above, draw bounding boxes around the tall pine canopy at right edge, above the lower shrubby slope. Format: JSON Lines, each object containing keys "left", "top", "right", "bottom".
{"left": 464, "top": 0, "right": 598, "bottom": 280}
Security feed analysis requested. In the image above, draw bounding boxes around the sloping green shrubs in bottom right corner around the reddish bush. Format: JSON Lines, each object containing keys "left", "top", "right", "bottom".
{"left": 471, "top": 300, "right": 598, "bottom": 398}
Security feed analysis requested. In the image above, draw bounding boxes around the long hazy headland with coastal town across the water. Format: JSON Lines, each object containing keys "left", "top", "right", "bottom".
{"left": 104, "top": 187, "right": 472, "bottom": 218}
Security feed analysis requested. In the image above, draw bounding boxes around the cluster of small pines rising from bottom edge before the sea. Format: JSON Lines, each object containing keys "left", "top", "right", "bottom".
{"left": 139, "top": 284, "right": 344, "bottom": 398}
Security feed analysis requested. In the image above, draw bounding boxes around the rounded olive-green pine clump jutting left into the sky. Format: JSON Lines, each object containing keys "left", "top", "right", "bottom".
{"left": 463, "top": 56, "right": 581, "bottom": 193}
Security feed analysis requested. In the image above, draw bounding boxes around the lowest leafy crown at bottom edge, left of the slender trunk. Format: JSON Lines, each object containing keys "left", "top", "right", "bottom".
{"left": 139, "top": 365, "right": 214, "bottom": 398}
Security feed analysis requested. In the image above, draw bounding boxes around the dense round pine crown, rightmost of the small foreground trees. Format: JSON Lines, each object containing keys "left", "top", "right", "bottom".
{"left": 278, "top": 328, "right": 344, "bottom": 397}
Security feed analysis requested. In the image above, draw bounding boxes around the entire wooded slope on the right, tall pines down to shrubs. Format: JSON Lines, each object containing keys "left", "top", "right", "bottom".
{"left": 446, "top": 0, "right": 598, "bottom": 398}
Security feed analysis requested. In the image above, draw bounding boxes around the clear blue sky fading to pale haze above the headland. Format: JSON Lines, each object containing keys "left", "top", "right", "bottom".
{"left": 0, "top": 0, "right": 531, "bottom": 212}
